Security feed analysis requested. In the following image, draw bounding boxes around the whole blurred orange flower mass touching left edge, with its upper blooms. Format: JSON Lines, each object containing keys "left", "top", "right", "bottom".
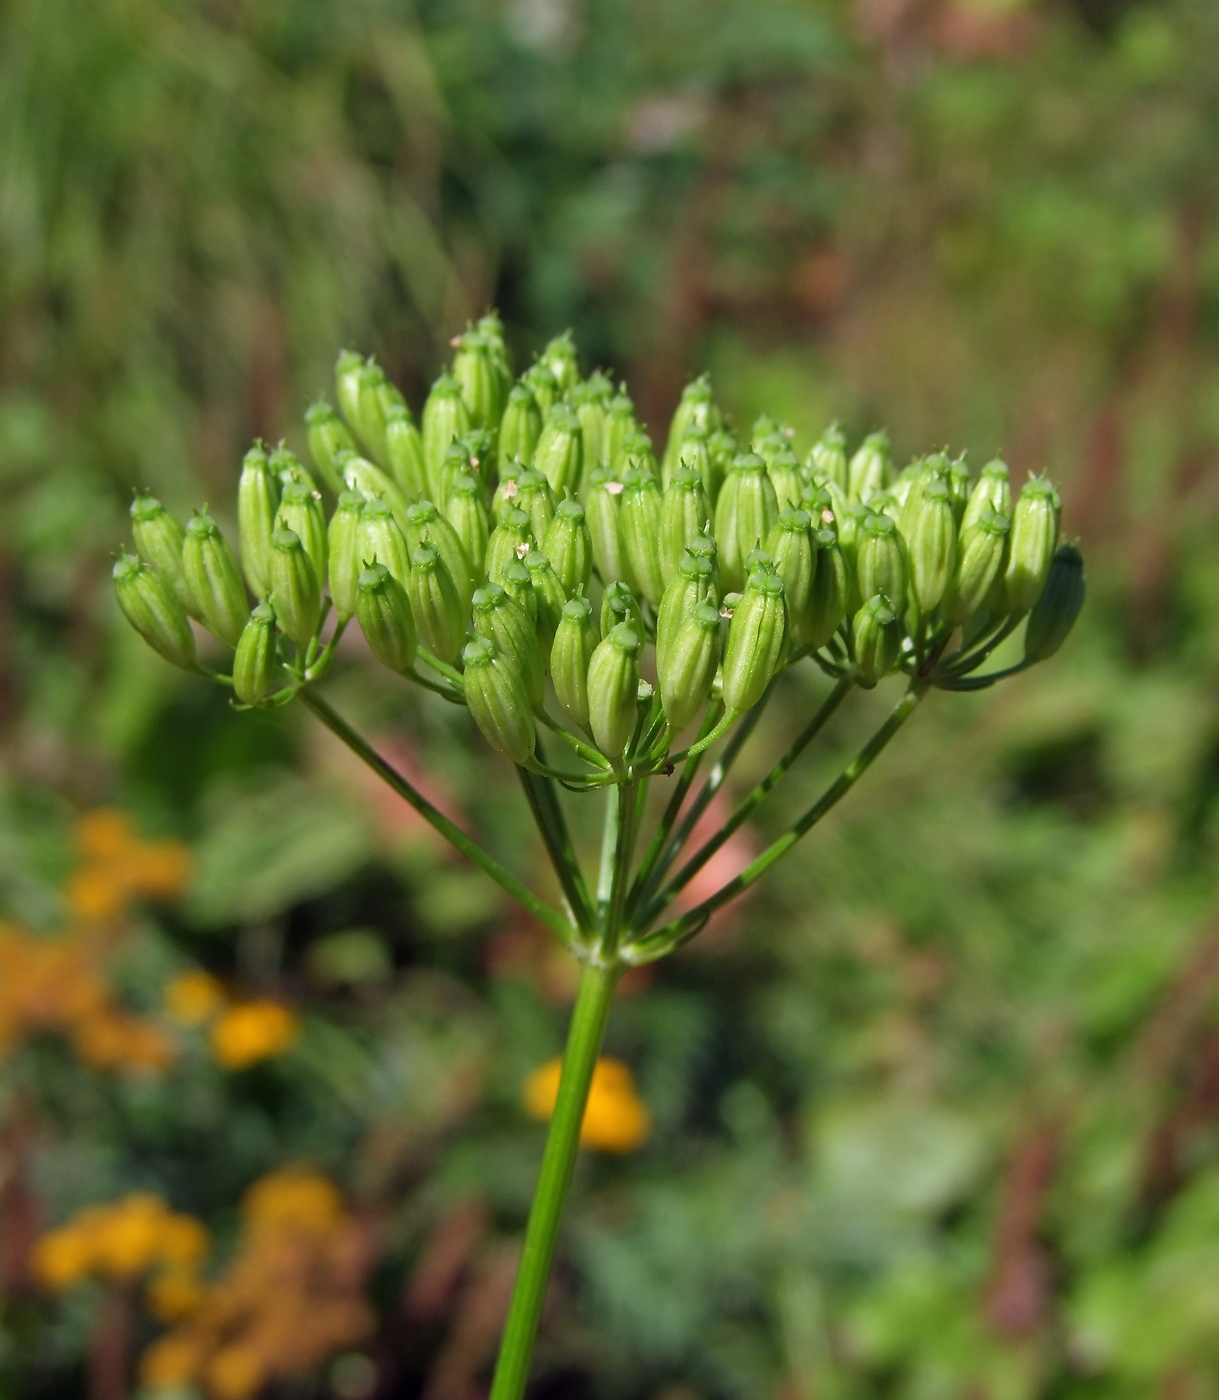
{"left": 0, "top": 809, "right": 189, "bottom": 1070}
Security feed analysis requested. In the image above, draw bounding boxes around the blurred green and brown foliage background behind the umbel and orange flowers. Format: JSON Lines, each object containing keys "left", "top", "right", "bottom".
{"left": 0, "top": 0, "right": 1219, "bottom": 1400}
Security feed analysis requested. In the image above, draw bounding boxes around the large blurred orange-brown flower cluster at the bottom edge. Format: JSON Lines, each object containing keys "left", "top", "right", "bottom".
{"left": 140, "top": 1170, "right": 375, "bottom": 1400}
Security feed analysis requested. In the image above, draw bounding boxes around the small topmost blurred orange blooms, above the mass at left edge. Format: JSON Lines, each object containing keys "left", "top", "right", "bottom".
{"left": 64, "top": 808, "right": 190, "bottom": 923}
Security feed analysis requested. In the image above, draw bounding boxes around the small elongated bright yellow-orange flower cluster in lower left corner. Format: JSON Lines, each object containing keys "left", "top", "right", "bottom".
{"left": 32, "top": 1193, "right": 209, "bottom": 1292}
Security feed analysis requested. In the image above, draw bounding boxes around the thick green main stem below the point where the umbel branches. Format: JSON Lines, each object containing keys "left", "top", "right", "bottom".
{"left": 490, "top": 963, "right": 620, "bottom": 1400}
